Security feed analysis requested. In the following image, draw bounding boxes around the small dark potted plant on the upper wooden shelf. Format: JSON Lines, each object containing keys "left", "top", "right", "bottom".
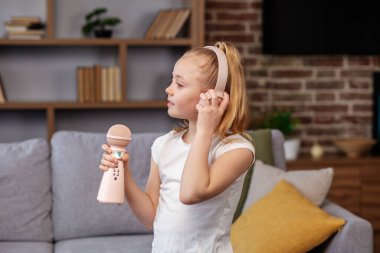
{"left": 82, "top": 7, "right": 121, "bottom": 38}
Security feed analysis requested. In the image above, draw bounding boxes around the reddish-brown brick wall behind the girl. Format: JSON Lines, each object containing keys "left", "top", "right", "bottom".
{"left": 206, "top": 0, "right": 380, "bottom": 153}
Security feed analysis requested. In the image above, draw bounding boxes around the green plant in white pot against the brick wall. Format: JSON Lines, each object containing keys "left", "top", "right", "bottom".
{"left": 260, "top": 111, "right": 300, "bottom": 160}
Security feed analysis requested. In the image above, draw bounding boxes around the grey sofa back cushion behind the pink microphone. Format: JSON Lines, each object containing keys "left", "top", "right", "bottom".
{"left": 51, "top": 131, "right": 162, "bottom": 240}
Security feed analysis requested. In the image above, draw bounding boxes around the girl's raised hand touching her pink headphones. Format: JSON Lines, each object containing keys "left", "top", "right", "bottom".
{"left": 196, "top": 89, "right": 229, "bottom": 133}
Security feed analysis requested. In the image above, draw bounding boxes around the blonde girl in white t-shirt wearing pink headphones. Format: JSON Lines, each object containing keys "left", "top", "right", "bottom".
{"left": 99, "top": 42, "right": 254, "bottom": 253}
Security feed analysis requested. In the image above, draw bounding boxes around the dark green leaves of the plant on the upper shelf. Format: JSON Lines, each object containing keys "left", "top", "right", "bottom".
{"left": 82, "top": 7, "right": 121, "bottom": 36}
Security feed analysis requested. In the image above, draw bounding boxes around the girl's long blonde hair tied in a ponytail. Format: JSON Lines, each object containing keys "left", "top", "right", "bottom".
{"left": 174, "top": 42, "right": 249, "bottom": 140}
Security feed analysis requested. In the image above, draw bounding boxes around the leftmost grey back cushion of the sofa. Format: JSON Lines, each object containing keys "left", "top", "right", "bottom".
{"left": 0, "top": 139, "right": 53, "bottom": 241}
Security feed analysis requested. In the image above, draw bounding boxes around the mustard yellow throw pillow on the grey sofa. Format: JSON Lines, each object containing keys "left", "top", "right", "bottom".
{"left": 231, "top": 180, "right": 345, "bottom": 253}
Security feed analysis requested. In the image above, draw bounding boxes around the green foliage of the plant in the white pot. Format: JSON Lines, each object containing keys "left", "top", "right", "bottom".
{"left": 260, "top": 111, "right": 299, "bottom": 137}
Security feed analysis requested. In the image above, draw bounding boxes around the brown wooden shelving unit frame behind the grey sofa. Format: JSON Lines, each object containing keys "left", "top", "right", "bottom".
{"left": 0, "top": 0, "right": 205, "bottom": 139}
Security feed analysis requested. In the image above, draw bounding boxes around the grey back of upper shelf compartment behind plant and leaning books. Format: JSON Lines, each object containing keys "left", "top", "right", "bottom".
{"left": 54, "top": 0, "right": 191, "bottom": 38}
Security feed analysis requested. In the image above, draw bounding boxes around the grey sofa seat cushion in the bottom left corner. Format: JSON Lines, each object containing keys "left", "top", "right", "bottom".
{"left": 0, "top": 242, "right": 53, "bottom": 253}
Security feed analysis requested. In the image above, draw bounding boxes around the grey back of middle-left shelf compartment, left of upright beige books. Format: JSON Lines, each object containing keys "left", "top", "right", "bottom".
{"left": 0, "top": 46, "right": 120, "bottom": 102}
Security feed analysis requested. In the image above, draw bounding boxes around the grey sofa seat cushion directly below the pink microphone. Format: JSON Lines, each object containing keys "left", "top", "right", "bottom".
{"left": 54, "top": 234, "right": 153, "bottom": 253}
